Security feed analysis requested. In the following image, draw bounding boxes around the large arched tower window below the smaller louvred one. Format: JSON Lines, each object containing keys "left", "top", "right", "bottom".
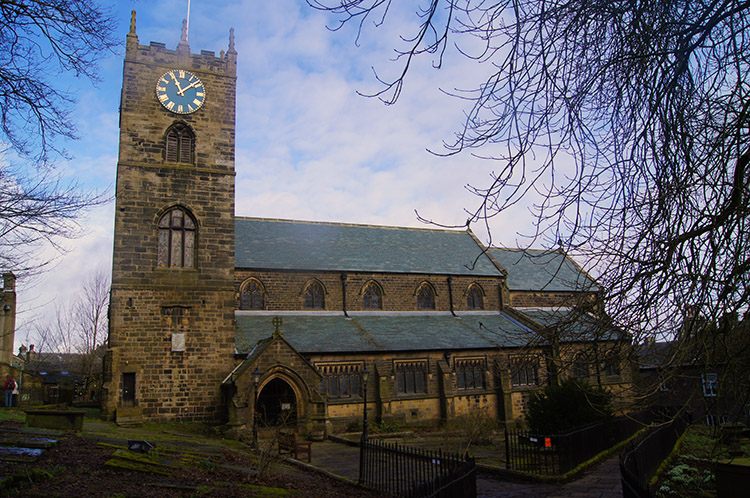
{"left": 157, "top": 207, "right": 197, "bottom": 268}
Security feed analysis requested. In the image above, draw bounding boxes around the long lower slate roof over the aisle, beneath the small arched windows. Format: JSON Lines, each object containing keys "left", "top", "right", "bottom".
{"left": 235, "top": 313, "right": 539, "bottom": 354}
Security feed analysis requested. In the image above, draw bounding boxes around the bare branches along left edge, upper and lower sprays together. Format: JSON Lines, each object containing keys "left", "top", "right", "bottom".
{"left": 0, "top": 0, "right": 116, "bottom": 274}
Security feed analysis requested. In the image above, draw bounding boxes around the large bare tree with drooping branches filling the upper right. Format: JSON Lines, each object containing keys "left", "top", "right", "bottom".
{"left": 308, "top": 0, "right": 750, "bottom": 416}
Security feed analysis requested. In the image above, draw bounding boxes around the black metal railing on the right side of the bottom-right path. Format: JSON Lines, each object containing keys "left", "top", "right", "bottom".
{"left": 620, "top": 417, "right": 688, "bottom": 498}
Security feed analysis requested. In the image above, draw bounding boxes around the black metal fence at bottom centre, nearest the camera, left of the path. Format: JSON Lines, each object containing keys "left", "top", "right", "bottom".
{"left": 359, "top": 440, "right": 477, "bottom": 498}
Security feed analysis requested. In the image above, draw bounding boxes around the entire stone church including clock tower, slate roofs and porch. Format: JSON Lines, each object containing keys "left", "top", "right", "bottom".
{"left": 102, "top": 13, "right": 632, "bottom": 433}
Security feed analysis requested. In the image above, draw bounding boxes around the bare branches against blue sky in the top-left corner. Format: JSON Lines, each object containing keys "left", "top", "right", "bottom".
{"left": 0, "top": 0, "right": 116, "bottom": 163}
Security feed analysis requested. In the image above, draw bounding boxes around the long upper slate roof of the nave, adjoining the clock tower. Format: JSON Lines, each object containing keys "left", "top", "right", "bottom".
{"left": 235, "top": 218, "right": 501, "bottom": 276}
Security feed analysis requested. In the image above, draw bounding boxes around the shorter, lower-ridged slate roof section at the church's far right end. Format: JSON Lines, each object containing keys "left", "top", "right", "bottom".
{"left": 489, "top": 247, "right": 599, "bottom": 292}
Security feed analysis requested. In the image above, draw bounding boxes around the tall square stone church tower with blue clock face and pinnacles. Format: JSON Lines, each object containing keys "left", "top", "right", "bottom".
{"left": 102, "top": 12, "right": 237, "bottom": 422}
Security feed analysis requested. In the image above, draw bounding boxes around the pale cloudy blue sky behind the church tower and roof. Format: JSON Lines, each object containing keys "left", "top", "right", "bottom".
{"left": 16, "top": 0, "right": 532, "bottom": 350}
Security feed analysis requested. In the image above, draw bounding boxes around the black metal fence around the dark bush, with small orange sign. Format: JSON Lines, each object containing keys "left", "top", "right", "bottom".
{"left": 505, "top": 412, "right": 649, "bottom": 475}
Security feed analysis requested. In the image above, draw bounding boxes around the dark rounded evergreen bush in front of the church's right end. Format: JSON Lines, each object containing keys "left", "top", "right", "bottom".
{"left": 526, "top": 379, "right": 612, "bottom": 434}
